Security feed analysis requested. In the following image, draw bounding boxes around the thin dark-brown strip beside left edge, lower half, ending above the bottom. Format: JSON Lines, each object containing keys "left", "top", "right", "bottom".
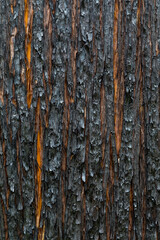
{"left": 2, "top": 139, "right": 10, "bottom": 210}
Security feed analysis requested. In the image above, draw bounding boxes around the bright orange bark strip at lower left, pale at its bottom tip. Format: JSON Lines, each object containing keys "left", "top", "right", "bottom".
{"left": 35, "top": 98, "right": 43, "bottom": 228}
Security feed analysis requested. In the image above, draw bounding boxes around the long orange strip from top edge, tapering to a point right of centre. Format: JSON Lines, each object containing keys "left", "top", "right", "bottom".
{"left": 113, "top": 0, "right": 124, "bottom": 157}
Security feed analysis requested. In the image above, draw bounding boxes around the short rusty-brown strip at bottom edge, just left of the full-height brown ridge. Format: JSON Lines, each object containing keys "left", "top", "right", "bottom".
{"left": 128, "top": 181, "right": 134, "bottom": 240}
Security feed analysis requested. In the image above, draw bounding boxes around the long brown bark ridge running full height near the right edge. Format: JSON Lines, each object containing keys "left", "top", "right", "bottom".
{"left": 134, "top": 0, "right": 147, "bottom": 237}
